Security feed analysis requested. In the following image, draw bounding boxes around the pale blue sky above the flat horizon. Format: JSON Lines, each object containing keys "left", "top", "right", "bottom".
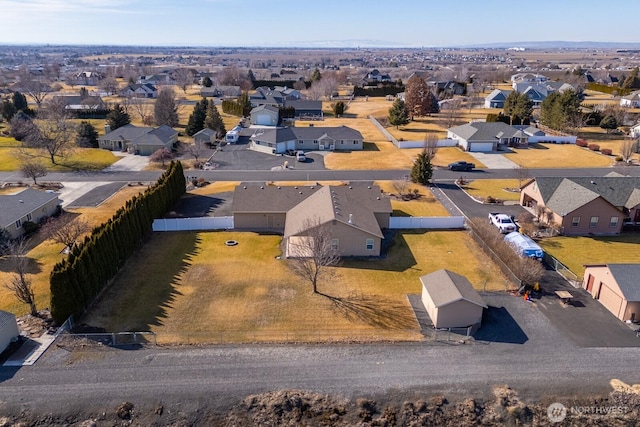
{"left": 0, "top": 0, "right": 640, "bottom": 47}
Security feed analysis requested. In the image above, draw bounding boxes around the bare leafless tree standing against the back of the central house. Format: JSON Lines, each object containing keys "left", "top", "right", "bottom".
{"left": 286, "top": 218, "right": 340, "bottom": 294}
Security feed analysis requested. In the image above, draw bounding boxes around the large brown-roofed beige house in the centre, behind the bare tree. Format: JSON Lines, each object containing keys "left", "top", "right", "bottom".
{"left": 232, "top": 185, "right": 392, "bottom": 257}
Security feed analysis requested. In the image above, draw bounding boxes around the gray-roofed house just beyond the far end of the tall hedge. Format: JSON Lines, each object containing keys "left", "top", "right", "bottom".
{"left": 98, "top": 124, "right": 178, "bottom": 156}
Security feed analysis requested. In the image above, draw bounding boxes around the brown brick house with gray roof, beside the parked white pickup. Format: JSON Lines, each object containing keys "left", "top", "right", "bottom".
{"left": 520, "top": 174, "right": 640, "bottom": 235}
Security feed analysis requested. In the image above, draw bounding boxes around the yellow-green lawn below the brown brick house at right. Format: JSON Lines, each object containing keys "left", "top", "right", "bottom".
{"left": 540, "top": 233, "right": 640, "bottom": 278}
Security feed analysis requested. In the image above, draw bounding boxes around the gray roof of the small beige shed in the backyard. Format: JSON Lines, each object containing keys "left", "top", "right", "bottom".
{"left": 420, "top": 269, "right": 487, "bottom": 308}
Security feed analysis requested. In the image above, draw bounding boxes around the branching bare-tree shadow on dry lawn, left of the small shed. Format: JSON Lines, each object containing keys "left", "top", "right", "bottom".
{"left": 318, "top": 292, "right": 416, "bottom": 330}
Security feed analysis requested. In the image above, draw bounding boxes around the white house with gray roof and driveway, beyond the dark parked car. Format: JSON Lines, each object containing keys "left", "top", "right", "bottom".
{"left": 447, "top": 122, "right": 529, "bottom": 152}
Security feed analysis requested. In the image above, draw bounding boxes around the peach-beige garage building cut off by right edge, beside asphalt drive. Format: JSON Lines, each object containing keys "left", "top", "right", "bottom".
{"left": 582, "top": 264, "right": 640, "bottom": 321}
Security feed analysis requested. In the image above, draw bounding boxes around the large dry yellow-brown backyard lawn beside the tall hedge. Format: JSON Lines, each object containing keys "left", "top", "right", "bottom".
{"left": 83, "top": 227, "right": 505, "bottom": 343}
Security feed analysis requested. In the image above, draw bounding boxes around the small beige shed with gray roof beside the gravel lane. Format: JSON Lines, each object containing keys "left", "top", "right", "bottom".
{"left": 420, "top": 269, "right": 487, "bottom": 328}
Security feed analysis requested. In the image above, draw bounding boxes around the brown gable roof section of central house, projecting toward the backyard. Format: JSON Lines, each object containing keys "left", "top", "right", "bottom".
{"left": 284, "top": 185, "right": 391, "bottom": 239}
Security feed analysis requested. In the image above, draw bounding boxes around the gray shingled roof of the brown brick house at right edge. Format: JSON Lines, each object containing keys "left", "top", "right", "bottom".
{"left": 535, "top": 176, "right": 640, "bottom": 214}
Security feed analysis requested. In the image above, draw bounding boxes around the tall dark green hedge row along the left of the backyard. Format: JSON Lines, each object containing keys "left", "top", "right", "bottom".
{"left": 49, "top": 162, "right": 186, "bottom": 324}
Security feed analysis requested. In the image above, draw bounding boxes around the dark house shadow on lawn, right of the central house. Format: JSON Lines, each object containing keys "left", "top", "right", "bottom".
{"left": 340, "top": 230, "right": 425, "bottom": 271}
